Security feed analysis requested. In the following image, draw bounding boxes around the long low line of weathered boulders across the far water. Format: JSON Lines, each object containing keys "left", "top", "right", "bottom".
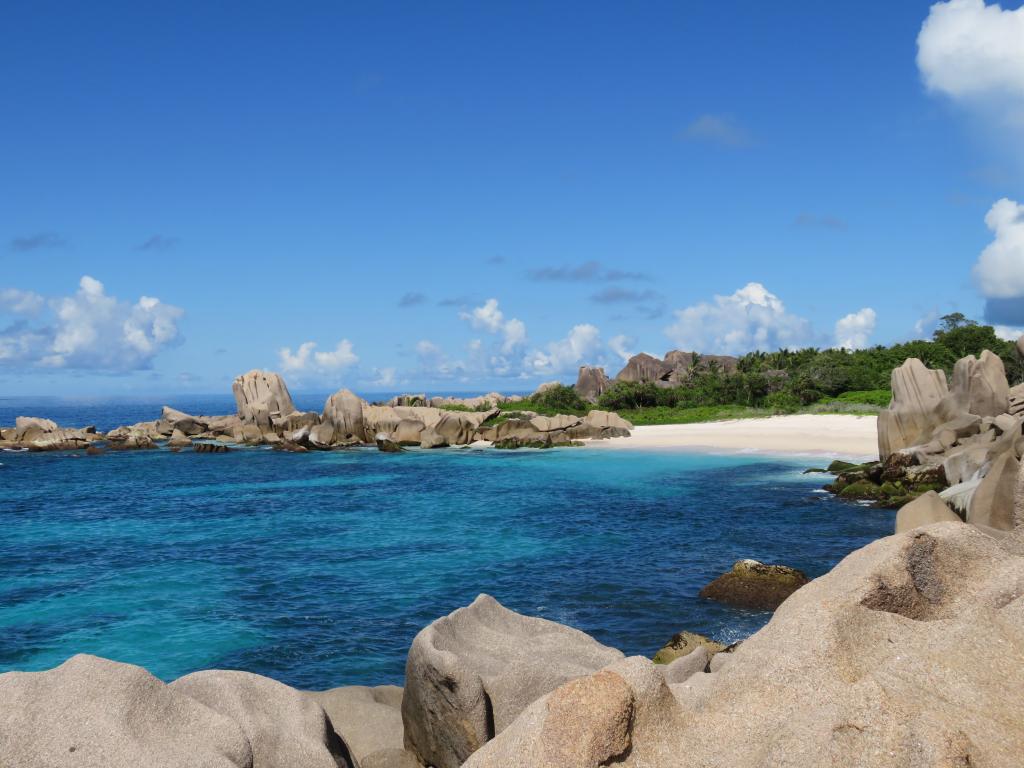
{"left": 0, "top": 371, "right": 633, "bottom": 453}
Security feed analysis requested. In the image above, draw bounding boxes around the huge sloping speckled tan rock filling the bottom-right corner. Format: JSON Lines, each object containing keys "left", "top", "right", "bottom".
{"left": 466, "top": 523, "right": 1024, "bottom": 768}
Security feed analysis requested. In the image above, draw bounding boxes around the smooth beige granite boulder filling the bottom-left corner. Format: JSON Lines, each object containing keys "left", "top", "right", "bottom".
{"left": 0, "top": 655, "right": 253, "bottom": 768}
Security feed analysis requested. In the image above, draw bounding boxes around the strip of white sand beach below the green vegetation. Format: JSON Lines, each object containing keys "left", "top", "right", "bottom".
{"left": 587, "top": 414, "right": 879, "bottom": 460}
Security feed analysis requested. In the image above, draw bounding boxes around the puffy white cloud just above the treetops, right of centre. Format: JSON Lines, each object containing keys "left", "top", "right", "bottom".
{"left": 665, "top": 283, "right": 813, "bottom": 354}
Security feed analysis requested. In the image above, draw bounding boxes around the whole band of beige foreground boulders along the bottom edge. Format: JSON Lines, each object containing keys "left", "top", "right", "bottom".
{"left": 0, "top": 523, "right": 1024, "bottom": 768}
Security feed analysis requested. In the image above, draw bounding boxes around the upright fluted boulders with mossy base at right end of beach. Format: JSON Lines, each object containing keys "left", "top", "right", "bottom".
{"left": 829, "top": 340, "right": 1024, "bottom": 531}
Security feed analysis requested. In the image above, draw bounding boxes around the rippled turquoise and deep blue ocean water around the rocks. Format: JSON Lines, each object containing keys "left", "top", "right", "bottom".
{"left": 0, "top": 402, "right": 893, "bottom": 688}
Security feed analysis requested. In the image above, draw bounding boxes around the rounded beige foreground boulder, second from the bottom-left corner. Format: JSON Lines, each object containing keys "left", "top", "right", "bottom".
{"left": 168, "top": 670, "right": 352, "bottom": 768}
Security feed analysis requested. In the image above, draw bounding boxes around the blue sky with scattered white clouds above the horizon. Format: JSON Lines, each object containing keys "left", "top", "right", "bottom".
{"left": 0, "top": 0, "right": 1024, "bottom": 394}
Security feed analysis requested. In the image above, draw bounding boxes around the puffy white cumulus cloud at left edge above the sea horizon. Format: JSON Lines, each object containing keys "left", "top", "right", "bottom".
{"left": 0, "top": 275, "right": 184, "bottom": 372}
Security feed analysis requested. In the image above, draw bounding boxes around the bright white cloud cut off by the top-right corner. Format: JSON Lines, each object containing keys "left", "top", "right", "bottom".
{"left": 918, "top": 0, "right": 1024, "bottom": 99}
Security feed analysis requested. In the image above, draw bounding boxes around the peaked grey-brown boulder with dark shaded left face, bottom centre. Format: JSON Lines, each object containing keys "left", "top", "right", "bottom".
{"left": 401, "top": 595, "right": 623, "bottom": 768}
